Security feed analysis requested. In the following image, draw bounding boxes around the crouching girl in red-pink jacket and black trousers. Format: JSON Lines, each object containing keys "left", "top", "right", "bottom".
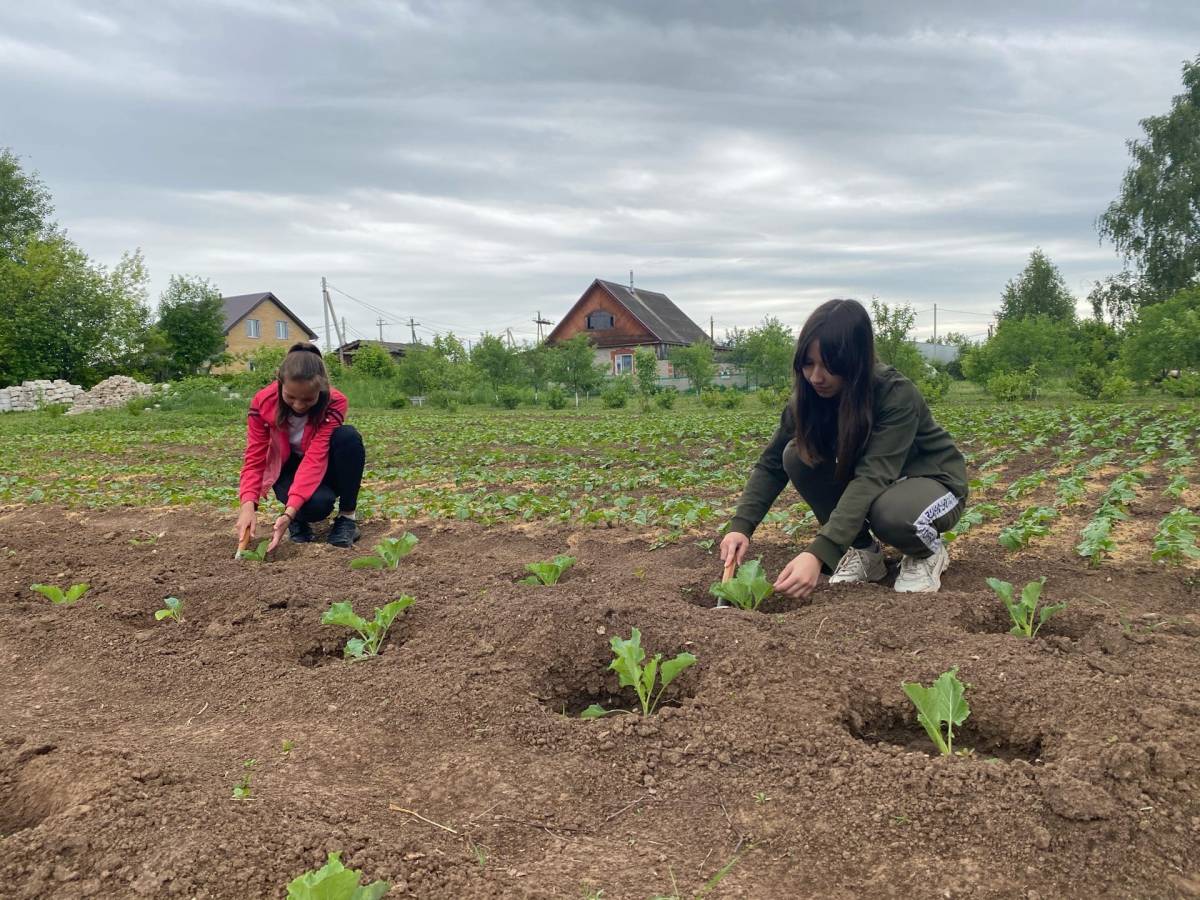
{"left": 238, "top": 343, "right": 366, "bottom": 548}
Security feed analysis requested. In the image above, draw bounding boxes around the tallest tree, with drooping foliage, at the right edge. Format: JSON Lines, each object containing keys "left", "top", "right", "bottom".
{"left": 1097, "top": 55, "right": 1200, "bottom": 300}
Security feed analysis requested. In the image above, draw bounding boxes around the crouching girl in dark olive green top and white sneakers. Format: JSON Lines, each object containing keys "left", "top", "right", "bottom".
{"left": 721, "top": 300, "right": 967, "bottom": 599}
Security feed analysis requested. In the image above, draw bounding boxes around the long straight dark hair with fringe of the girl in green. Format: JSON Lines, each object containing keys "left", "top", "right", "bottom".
{"left": 792, "top": 300, "right": 875, "bottom": 481}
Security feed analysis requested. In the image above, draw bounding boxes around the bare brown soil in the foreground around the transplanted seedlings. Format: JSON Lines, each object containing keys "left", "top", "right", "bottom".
{"left": 0, "top": 506, "right": 1200, "bottom": 900}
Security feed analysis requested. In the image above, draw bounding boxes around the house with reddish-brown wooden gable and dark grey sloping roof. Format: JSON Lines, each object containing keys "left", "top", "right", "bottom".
{"left": 546, "top": 278, "right": 712, "bottom": 378}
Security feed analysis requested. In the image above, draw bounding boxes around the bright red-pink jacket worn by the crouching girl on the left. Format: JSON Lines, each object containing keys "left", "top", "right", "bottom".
{"left": 238, "top": 382, "right": 348, "bottom": 509}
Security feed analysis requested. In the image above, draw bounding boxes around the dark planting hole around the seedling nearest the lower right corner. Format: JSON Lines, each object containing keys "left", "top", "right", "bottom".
{"left": 844, "top": 703, "right": 1042, "bottom": 762}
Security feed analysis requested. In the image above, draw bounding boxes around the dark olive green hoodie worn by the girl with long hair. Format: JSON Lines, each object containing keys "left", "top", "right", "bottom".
{"left": 730, "top": 365, "right": 967, "bottom": 569}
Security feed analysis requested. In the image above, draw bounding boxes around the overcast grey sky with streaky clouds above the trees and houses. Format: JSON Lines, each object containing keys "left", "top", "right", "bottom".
{"left": 0, "top": 0, "right": 1200, "bottom": 341}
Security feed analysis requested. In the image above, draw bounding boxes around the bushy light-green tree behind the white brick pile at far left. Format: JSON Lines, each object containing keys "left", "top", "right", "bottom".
{"left": 0, "top": 235, "right": 148, "bottom": 385}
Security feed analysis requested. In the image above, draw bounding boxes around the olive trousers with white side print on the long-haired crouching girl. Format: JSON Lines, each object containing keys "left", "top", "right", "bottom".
{"left": 784, "top": 444, "right": 962, "bottom": 559}
